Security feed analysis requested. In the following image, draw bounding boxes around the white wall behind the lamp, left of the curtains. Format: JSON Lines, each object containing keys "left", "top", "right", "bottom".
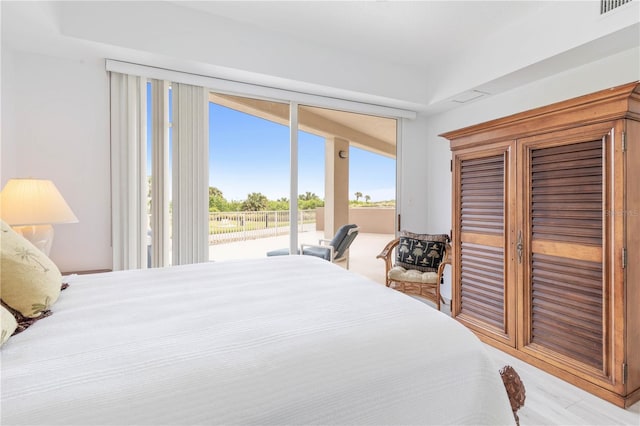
{"left": 1, "top": 49, "right": 111, "bottom": 271}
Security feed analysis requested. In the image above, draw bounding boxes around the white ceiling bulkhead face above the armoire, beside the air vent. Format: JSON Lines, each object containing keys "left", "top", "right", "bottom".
{"left": 434, "top": 0, "right": 640, "bottom": 100}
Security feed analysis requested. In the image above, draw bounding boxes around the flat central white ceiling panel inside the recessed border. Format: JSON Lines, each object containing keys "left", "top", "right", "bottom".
{"left": 174, "top": 0, "right": 545, "bottom": 71}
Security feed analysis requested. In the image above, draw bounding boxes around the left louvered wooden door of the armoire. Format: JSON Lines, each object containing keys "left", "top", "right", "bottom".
{"left": 452, "top": 141, "right": 515, "bottom": 346}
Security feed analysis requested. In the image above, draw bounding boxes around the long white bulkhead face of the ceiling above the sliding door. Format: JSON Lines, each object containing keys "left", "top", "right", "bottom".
{"left": 55, "top": 2, "right": 426, "bottom": 111}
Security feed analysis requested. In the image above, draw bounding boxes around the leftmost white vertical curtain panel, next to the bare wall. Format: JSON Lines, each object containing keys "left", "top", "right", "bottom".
{"left": 110, "top": 72, "right": 148, "bottom": 270}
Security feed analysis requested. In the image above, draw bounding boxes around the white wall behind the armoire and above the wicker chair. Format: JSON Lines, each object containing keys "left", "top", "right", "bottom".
{"left": 400, "top": 48, "right": 640, "bottom": 297}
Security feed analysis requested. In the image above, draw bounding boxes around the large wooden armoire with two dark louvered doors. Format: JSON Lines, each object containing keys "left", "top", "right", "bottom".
{"left": 441, "top": 82, "right": 640, "bottom": 407}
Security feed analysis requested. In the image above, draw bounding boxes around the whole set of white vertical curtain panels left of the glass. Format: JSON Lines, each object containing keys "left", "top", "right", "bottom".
{"left": 110, "top": 72, "right": 209, "bottom": 270}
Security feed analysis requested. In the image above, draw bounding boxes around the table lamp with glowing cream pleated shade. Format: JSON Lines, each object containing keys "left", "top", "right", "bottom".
{"left": 0, "top": 178, "right": 78, "bottom": 256}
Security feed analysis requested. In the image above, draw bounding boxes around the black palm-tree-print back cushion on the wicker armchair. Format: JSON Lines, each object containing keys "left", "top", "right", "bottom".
{"left": 395, "top": 231, "right": 449, "bottom": 272}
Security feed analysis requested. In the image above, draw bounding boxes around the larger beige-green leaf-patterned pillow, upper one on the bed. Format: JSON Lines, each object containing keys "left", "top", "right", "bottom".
{"left": 0, "top": 221, "right": 62, "bottom": 318}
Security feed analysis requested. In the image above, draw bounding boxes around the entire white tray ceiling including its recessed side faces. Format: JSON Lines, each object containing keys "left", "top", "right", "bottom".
{"left": 0, "top": 0, "right": 640, "bottom": 120}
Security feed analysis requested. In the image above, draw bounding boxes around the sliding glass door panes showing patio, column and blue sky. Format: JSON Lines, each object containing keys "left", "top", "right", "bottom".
{"left": 209, "top": 93, "right": 396, "bottom": 260}
